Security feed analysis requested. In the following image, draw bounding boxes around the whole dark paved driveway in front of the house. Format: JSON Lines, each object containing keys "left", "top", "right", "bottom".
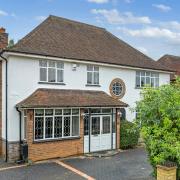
{"left": 0, "top": 148, "right": 153, "bottom": 180}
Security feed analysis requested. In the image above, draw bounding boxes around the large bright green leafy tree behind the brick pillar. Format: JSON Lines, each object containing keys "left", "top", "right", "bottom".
{"left": 136, "top": 78, "right": 180, "bottom": 178}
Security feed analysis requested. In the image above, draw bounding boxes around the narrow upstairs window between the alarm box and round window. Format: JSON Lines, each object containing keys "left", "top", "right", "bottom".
{"left": 87, "top": 65, "right": 99, "bottom": 85}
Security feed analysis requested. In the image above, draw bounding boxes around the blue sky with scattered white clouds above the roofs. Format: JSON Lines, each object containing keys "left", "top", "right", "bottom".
{"left": 0, "top": 0, "right": 180, "bottom": 59}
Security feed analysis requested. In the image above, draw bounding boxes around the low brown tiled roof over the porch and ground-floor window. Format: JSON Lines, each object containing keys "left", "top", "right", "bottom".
{"left": 16, "top": 89, "right": 127, "bottom": 108}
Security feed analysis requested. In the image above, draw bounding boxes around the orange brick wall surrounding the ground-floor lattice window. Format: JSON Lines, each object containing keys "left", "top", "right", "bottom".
{"left": 26, "top": 110, "right": 84, "bottom": 161}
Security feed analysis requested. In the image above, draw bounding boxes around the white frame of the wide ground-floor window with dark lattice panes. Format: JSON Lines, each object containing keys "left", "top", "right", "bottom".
{"left": 34, "top": 108, "right": 80, "bottom": 141}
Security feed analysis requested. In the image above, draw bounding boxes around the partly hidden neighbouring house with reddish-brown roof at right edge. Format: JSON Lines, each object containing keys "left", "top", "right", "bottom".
{"left": 158, "top": 54, "right": 180, "bottom": 81}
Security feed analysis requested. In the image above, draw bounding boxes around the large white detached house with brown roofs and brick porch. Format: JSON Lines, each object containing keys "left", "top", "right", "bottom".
{"left": 0, "top": 16, "right": 171, "bottom": 161}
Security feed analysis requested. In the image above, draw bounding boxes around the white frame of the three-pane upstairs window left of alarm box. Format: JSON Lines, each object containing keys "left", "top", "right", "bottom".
{"left": 39, "top": 60, "right": 64, "bottom": 84}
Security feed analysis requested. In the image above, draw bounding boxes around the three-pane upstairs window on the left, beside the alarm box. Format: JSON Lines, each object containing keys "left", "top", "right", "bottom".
{"left": 39, "top": 60, "right": 64, "bottom": 83}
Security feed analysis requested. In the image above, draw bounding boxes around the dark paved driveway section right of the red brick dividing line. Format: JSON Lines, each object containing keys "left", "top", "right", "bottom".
{"left": 64, "top": 148, "right": 153, "bottom": 180}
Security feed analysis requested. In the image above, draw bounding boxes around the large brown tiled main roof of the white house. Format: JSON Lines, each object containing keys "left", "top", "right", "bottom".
{"left": 7, "top": 16, "right": 170, "bottom": 71}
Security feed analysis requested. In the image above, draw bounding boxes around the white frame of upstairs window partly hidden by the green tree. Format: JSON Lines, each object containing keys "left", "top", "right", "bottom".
{"left": 135, "top": 71, "right": 159, "bottom": 88}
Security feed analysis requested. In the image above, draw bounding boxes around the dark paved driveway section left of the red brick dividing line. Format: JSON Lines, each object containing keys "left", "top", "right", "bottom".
{"left": 0, "top": 163, "right": 84, "bottom": 180}
